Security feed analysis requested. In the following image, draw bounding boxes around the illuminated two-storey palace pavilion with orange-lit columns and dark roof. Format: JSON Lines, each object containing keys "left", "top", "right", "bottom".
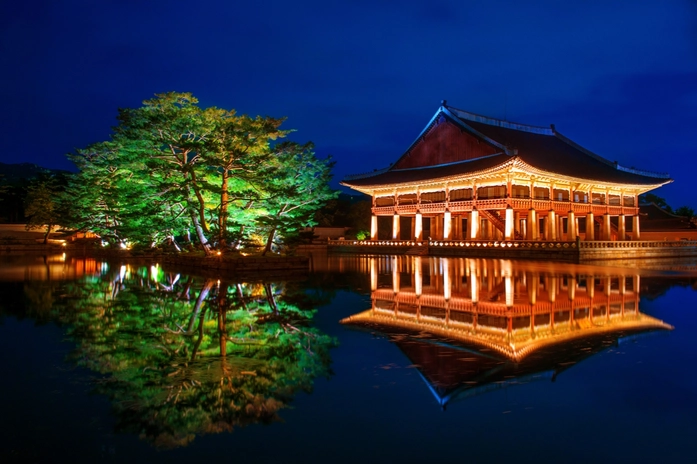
{"left": 342, "top": 101, "right": 672, "bottom": 241}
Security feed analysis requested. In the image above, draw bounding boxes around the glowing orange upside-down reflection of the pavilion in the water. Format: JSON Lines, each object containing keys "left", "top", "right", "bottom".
{"left": 342, "top": 256, "right": 672, "bottom": 403}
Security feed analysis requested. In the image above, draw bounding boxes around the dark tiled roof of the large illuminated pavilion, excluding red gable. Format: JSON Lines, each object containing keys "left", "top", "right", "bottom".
{"left": 342, "top": 104, "right": 671, "bottom": 187}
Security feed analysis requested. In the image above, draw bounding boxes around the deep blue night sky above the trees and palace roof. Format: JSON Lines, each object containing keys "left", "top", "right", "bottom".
{"left": 0, "top": 0, "right": 697, "bottom": 209}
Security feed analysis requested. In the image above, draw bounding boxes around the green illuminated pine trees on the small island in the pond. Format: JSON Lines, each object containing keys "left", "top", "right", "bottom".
{"left": 64, "top": 92, "right": 336, "bottom": 253}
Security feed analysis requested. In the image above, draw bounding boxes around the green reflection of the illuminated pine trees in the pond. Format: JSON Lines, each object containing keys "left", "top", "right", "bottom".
{"left": 40, "top": 270, "right": 334, "bottom": 447}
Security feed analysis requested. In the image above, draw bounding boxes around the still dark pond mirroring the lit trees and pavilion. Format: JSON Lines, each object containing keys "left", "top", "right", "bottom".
{"left": 0, "top": 255, "right": 697, "bottom": 463}
